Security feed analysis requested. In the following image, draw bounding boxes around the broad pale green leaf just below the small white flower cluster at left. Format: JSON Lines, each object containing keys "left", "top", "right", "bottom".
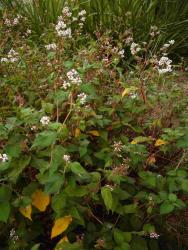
{"left": 32, "top": 131, "right": 57, "bottom": 149}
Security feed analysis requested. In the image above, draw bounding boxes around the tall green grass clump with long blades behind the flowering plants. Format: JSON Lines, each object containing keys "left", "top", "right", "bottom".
{"left": 0, "top": 0, "right": 188, "bottom": 57}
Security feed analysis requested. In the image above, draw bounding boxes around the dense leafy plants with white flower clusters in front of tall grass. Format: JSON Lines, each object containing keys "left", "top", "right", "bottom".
{"left": 0, "top": 0, "right": 188, "bottom": 250}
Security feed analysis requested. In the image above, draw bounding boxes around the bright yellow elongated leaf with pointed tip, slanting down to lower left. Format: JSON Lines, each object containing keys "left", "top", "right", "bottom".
{"left": 51, "top": 215, "right": 72, "bottom": 239}
